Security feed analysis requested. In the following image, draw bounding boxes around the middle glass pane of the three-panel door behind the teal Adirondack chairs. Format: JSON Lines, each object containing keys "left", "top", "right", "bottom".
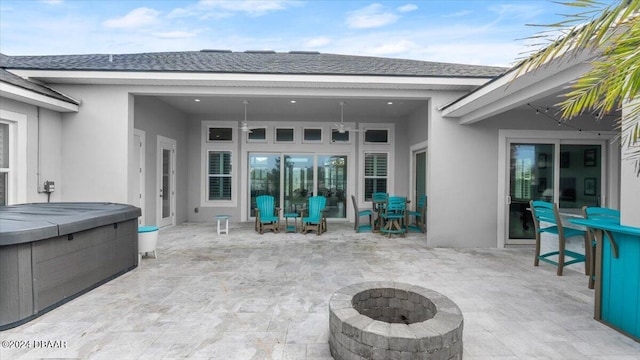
{"left": 283, "top": 155, "right": 313, "bottom": 213}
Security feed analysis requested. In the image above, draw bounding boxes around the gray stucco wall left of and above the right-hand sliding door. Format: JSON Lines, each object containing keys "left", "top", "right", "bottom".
{"left": 427, "top": 98, "right": 612, "bottom": 247}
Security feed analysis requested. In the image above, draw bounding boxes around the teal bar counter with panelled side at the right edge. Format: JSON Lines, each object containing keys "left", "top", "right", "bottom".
{"left": 570, "top": 219, "right": 640, "bottom": 341}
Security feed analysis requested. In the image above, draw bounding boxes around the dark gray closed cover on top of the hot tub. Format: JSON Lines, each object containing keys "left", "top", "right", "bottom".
{"left": 0, "top": 202, "right": 142, "bottom": 246}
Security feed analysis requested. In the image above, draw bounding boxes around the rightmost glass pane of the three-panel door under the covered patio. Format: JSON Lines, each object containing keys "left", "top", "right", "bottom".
{"left": 318, "top": 155, "right": 347, "bottom": 218}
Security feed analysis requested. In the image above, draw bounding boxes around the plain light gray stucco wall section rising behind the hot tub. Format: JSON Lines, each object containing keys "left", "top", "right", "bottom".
{"left": 52, "top": 84, "right": 132, "bottom": 204}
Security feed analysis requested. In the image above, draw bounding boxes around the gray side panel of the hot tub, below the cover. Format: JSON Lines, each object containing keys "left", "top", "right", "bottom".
{"left": 0, "top": 218, "right": 138, "bottom": 331}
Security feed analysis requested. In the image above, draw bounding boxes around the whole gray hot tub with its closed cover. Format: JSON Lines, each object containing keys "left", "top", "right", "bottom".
{"left": 0, "top": 203, "right": 141, "bottom": 330}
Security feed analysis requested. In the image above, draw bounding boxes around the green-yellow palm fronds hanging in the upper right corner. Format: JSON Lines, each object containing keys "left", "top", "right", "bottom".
{"left": 518, "top": 0, "right": 640, "bottom": 169}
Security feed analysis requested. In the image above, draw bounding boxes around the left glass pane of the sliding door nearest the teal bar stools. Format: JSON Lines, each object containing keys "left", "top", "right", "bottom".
{"left": 508, "top": 143, "right": 554, "bottom": 239}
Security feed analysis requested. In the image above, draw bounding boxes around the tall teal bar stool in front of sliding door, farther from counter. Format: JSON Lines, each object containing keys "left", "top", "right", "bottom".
{"left": 529, "top": 200, "right": 588, "bottom": 276}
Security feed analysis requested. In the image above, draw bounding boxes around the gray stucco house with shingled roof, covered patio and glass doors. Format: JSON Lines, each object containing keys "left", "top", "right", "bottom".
{"left": 0, "top": 50, "right": 640, "bottom": 247}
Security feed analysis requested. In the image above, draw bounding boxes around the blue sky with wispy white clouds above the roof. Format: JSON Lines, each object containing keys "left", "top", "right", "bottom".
{"left": 0, "top": 0, "right": 612, "bottom": 66}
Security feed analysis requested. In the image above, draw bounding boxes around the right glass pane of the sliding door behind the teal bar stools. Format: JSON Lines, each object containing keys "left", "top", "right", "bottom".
{"left": 558, "top": 145, "right": 602, "bottom": 209}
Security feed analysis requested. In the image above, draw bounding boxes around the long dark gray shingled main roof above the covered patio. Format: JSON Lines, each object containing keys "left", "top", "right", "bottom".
{"left": 0, "top": 50, "right": 507, "bottom": 78}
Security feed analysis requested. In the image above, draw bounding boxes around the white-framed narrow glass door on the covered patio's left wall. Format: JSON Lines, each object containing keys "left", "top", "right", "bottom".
{"left": 156, "top": 136, "right": 176, "bottom": 227}
